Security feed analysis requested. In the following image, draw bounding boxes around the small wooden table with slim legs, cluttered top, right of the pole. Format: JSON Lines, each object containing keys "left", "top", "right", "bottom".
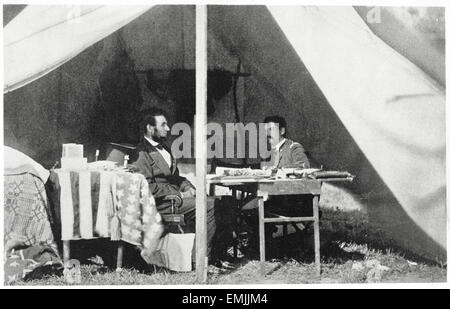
{"left": 207, "top": 175, "right": 323, "bottom": 275}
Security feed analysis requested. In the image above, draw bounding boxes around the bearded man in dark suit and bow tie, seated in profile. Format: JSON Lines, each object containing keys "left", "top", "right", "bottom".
{"left": 127, "top": 108, "right": 231, "bottom": 262}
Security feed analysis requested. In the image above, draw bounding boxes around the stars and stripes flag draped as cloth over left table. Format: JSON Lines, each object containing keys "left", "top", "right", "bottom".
{"left": 50, "top": 169, "right": 163, "bottom": 255}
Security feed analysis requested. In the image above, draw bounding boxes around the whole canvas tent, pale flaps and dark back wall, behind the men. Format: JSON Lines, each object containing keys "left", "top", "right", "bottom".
{"left": 4, "top": 6, "right": 446, "bottom": 260}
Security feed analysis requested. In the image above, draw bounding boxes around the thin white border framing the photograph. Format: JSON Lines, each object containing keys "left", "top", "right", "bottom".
{"left": 0, "top": 0, "right": 450, "bottom": 293}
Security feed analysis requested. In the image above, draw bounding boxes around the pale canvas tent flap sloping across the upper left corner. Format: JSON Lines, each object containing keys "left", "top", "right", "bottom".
{"left": 4, "top": 5, "right": 151, "bottom": 93}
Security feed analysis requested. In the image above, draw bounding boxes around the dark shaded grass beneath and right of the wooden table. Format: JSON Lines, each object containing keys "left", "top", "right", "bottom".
{"left": 230, "top": 205, "right": 442, "bottom": 267}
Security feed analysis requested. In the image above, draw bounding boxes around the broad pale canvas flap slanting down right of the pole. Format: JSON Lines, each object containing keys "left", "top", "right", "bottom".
{"left": 269, "top": 6, "right": 446, "bottom": 248}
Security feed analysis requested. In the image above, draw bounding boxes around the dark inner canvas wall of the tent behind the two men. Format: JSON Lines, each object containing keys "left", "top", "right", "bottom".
{"left": 3, "top": 5, "right": 445, "bottom": 258}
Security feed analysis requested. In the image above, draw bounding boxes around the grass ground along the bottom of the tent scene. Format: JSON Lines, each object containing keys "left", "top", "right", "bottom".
{"left": 13, "top": 205, "right": 446, "bottom": 285}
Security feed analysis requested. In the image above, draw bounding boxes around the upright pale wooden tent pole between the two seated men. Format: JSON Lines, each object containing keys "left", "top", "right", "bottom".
{"left": 195, "top": 5, "right": 208, "bottom": 283}
